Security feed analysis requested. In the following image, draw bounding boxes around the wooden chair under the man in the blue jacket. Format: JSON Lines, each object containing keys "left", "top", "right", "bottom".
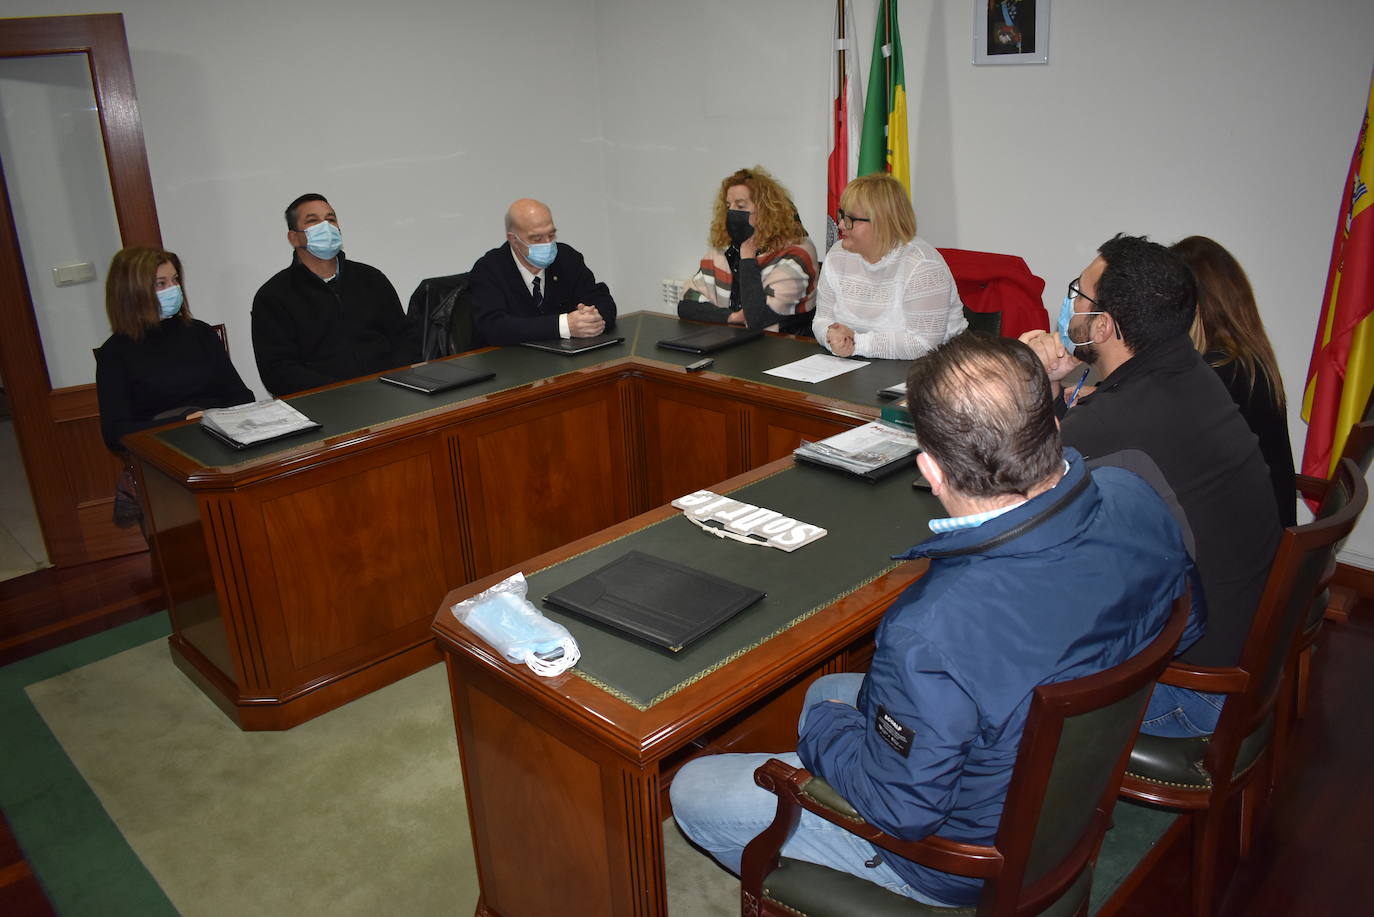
{"left": 741, "top": 594, "right": 1189, "bottom": 917}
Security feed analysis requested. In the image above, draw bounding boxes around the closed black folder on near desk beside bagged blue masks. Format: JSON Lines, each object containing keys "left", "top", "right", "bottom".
{"left": 544, "top": 551, "right": 764, "bottom": 653}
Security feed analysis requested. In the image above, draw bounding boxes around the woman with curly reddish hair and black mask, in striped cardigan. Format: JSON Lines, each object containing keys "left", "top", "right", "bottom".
{"left": 677, "top": 166, "right": 816, "bottom": 334}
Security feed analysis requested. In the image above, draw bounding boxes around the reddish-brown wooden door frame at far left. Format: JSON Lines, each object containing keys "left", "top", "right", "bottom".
{"left": 0, "top": 12, "right": 162, "bottom": 566}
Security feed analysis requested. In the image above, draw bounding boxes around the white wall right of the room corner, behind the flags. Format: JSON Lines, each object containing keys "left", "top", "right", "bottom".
{"left": 598, "top": 0, "right": 1374, "bottom": 568}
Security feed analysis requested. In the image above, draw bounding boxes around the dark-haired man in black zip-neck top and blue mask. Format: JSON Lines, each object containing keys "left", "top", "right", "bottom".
{"left": 253, "top": 194, "right": 419, "bottom": 396}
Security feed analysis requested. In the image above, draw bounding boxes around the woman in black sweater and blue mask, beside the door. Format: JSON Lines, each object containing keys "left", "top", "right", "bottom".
{"left": 95, "top": 247, "right": 253, "bottom": 454}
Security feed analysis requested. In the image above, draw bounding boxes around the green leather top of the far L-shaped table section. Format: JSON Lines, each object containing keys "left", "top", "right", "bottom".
{"left": 154, "top": 312, "right": 907, "bottom": 467}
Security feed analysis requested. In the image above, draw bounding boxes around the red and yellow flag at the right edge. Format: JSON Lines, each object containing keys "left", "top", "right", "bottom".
{"left": 1303, "top": 71, "right": 1374, "bottom": 477}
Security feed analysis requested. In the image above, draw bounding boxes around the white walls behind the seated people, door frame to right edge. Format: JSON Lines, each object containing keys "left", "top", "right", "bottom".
{"left": 8, "top": 0, "right": 1374, "bottom": 568}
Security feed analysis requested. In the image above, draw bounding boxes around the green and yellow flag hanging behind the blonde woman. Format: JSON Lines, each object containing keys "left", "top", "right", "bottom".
{"left": 859, "top": 0, "right": 911, "bottom": 194}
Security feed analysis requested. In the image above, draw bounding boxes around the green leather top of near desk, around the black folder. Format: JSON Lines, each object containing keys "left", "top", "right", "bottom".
{"left": 525, "top": 462, "right": 944, "bottom": 709}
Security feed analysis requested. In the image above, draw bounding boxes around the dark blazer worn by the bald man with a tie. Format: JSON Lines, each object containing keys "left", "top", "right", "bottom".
{"left": 469, "top": 242, "right": 616, "bottom": 346}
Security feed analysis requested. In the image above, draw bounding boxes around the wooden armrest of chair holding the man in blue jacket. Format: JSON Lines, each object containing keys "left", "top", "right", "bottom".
{"left": 754, "top": 758, "right": 1002, "bottom": 879}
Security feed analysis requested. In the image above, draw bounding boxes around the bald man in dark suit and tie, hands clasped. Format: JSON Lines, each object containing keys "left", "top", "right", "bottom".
{"left": 469, "top": 198, "right": 616, "bottom": 345}
